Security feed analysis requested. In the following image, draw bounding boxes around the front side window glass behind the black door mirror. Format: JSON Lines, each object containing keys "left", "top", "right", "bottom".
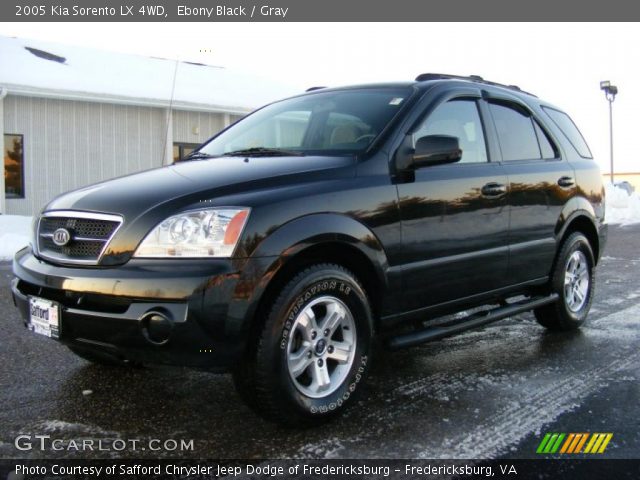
{"left": 413, "top": 100, "right": 487, "bottom": 163}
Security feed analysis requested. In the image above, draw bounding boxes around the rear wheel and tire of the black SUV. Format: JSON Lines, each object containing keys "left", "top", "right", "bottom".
{"left": 534, "top": 232, "right": 595, "bottom": 332}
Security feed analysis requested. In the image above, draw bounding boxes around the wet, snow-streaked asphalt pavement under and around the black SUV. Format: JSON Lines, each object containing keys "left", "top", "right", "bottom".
{"left": 0, "top": 226, "right": 640, "bottom": 459}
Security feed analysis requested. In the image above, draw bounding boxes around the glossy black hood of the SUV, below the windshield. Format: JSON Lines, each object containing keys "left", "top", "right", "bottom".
{"left": 45, "top": 156, "right": 355, "bottom": 265}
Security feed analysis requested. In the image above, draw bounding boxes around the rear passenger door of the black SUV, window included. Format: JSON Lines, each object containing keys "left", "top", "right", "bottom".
{"left": 488, "top": 98, "right": 576, "bottom": 284}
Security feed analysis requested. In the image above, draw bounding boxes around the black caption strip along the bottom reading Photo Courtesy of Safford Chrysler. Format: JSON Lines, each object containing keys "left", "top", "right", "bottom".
{"left": 0, "top": 458, "right": 640, "bottom": 480}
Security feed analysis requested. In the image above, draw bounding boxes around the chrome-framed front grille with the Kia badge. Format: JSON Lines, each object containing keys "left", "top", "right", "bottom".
{"left": 38, "top": 211, "right": 122, "bottom": 265}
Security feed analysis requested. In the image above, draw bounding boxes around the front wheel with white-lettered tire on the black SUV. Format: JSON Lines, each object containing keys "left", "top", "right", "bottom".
{"left": 233, "top": 264, "right": 373, "bottom": 427}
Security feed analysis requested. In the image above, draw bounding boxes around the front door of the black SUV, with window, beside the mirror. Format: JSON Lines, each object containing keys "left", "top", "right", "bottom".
{"left": 398, "top": 91, "right": 509, "bottom": 310}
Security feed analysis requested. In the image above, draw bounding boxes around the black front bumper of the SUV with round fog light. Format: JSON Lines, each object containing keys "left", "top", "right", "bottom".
{"left": 11, "top": 249, "right": 272, "bottom": 371}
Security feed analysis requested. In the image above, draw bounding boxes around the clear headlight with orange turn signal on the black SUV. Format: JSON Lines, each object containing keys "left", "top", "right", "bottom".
{"left": 134, "top": 208, "right": 249, "bottom": 258}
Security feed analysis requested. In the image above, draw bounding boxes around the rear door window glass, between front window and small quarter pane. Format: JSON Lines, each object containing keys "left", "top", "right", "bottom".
{"left": 489, "top": 103, "right": 542, "bottom": 161}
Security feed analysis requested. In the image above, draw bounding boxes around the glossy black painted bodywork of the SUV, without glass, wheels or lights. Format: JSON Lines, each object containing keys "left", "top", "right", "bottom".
{"left": 13, "top": 81, "right": 606, "bottom": 370}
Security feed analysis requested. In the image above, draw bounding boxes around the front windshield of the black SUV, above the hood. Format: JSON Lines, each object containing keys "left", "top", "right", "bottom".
{"left": 199, "top": 88, "right": 411, "bottom": 156}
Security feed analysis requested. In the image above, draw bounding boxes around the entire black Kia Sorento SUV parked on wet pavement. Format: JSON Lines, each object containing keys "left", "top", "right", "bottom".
{"left": 12, "top": 74, "right": 606, "bottom": 425}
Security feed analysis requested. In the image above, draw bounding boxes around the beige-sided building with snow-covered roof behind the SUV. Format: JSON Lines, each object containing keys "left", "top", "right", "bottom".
{"left": 0, "top": 37, "right": 296, "bottom": 215}
